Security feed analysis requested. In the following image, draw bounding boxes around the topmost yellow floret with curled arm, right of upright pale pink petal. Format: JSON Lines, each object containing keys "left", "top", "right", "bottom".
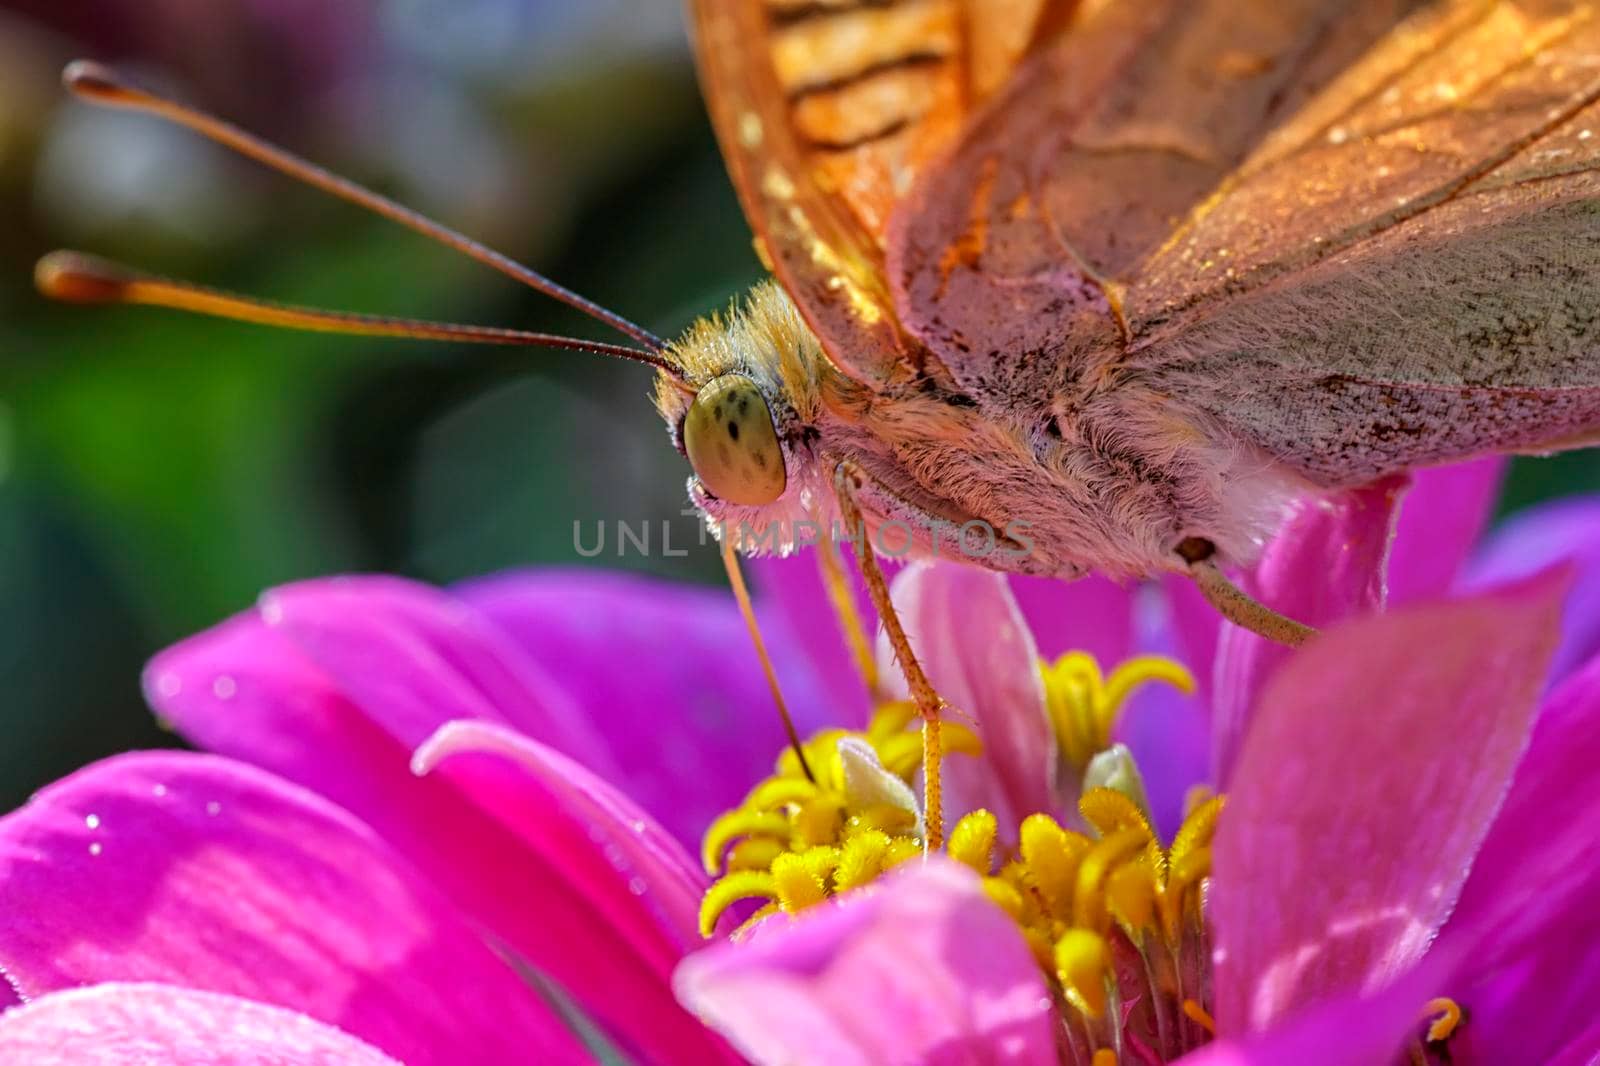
{"left": 1040, "top": 651, "right": 1195, "bottom": 771}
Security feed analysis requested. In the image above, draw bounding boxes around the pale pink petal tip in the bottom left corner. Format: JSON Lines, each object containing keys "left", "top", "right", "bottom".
{"left": 0, "top": 983, "right": 400, "bottom": 1066}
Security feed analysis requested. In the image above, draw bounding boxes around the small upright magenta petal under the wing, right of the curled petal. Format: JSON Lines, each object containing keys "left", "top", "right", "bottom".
{"left": 1389, "top": 456, "right": 1507, "bottom": 605}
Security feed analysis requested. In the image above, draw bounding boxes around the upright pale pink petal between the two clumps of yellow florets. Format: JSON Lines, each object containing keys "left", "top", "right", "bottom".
{"left": 891, "top": 563, "right": 1058, "bottom": 828}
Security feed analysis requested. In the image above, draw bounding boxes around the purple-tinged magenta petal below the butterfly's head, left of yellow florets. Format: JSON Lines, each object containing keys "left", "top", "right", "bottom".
{"left": 456, "top": 555, "right": 838, "bottom": 847}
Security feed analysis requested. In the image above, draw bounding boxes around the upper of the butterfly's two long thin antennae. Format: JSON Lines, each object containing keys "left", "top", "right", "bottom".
{"left": 61, "top": 59, "right": 668, "bottom": 352}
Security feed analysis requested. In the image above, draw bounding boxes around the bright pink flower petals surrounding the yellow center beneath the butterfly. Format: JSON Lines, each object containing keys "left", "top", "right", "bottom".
{"left": 0, "top": 454, "right": 1600, "bottom": 1066}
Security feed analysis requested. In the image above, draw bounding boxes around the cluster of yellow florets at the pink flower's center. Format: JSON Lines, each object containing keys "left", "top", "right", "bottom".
{"left": 699, "top": 651, "right": 1461, "bottom": 1066}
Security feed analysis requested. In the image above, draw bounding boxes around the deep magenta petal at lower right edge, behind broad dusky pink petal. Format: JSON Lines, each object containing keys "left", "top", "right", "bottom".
{"left": 1440, "top": 659, "right": 1600, "bottom": 1063}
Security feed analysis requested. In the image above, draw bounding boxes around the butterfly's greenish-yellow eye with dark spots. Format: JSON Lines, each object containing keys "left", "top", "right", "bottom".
{"left": 683, "top": 375, "right": 789, "bottom": 507}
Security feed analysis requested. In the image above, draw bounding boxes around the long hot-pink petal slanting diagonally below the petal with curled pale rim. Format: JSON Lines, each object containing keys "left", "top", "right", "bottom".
{"left": 146, "top": 615, "right": 732, "bottom": 1056}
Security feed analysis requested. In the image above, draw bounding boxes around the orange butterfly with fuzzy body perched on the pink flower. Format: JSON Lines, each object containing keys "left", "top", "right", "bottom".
{"left": 38, "top": 0, "right": 1600, "bottom": 658}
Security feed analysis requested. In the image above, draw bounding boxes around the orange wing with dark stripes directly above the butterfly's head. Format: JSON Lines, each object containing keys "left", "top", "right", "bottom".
{"left": 691, "top": 0, "right": 1077, "bottom": 386}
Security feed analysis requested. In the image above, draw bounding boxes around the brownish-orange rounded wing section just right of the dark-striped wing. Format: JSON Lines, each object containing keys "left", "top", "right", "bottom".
{"left": 888, "top": 0, "right": 1418, "bottom": 400}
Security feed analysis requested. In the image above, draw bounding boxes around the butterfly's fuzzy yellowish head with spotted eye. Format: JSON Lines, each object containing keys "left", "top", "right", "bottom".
{"left": 656, "top": 282, "right": 826, "bottom": 551}
